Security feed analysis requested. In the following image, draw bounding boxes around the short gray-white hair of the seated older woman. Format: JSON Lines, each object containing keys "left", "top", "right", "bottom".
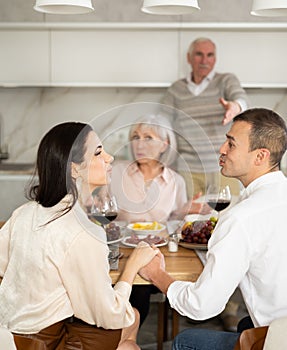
{"left": 129, "top": 114, "right": 177, "bottom": 166}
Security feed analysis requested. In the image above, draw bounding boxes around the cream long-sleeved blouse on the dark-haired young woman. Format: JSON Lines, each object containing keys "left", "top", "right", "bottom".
{"left": 0, "top": 196, "right": 134, "bottom": 334}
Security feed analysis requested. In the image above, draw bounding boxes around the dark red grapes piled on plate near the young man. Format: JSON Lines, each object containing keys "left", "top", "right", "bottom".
{"left": 181, "top": 217, "right": 217, "bottom": 244}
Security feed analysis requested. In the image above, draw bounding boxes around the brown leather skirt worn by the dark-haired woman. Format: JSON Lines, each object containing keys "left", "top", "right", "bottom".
{"left": 14, "top": 317, "right": 122, "bottom": 350}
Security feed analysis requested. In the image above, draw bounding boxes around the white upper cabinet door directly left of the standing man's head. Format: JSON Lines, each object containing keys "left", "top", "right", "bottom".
{"left": 51, "top": 29, "right": 178, "bottom": 86}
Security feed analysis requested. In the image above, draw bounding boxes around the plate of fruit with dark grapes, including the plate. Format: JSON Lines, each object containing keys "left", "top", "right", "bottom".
{"left": 179, "top": 216, "right": 217, "bottom": 250}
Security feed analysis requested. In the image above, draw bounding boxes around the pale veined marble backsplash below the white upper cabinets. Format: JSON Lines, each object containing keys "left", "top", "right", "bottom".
{"left": 0, "top": 87, "right": 287, "bottom": 171}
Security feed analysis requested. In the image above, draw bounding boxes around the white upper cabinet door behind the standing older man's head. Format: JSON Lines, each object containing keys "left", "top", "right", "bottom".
{"left": 180, "top": 28, "right": 287, "bottom": 86}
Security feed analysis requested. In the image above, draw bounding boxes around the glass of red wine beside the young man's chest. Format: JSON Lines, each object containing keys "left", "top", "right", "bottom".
{"left": 206, "top": 185, "right": 231, "bottom": 212}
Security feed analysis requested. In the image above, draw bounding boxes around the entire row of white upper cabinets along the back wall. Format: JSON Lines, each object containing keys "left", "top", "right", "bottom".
{"left": 0, "top": 23, "right": 287, "bottom": 88}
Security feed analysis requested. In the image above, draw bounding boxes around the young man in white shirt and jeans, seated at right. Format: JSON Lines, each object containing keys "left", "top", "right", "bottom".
{"left": 141, "top": 108, "right": 287, "bottom": 350}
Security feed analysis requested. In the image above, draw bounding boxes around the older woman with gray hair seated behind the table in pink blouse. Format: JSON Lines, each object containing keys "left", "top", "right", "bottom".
{"left": 111, "top": 115, "right": 210, "bottom": 324}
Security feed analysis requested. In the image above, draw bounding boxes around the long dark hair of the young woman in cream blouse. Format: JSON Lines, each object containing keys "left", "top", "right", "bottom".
{"left": 28, "top": 122, "right": 92, "bottom": 212}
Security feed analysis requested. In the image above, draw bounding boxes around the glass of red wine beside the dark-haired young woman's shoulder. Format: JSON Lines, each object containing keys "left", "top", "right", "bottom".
{"left": 89, "top": 193, "right": 118, "bottom": 228}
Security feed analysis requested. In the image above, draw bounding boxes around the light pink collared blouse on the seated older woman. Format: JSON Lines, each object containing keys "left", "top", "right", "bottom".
{"left": 111, "top": 161, "right": 187, "bottom": 222}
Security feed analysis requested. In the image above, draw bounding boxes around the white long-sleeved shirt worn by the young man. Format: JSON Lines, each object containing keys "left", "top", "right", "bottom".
{"left": 167, "top": 171, "right": 287, "bottom": 326}
